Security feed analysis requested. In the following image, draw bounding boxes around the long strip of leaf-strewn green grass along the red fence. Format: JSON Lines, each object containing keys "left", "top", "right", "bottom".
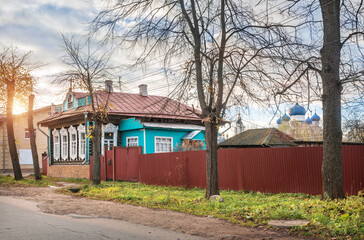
{"left": 76, "top": 182, "right": 364, "bottom": 239}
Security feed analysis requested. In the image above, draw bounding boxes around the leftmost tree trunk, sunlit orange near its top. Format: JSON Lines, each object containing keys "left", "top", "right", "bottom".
{"left": 6, "top": 82, "right": 23, "bottom": 180}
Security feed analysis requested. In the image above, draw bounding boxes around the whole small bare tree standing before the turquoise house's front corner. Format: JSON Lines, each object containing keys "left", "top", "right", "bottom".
{"left": 57, "top": 35, "right": 114, "bottom": 185}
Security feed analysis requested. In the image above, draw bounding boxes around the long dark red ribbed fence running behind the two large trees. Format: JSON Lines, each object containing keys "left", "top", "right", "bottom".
{"left": 139, "top": 146, "right": 364, "bottom": 195}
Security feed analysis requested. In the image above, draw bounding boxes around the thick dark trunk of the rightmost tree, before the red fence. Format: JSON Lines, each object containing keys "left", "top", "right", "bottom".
{"left": 320, "top": 0, "right": 345, "bottom": 199}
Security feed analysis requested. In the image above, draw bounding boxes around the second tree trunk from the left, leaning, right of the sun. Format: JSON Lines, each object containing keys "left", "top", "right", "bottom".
{"left": 28, "top": 94, "right": 42, "bottom": 180}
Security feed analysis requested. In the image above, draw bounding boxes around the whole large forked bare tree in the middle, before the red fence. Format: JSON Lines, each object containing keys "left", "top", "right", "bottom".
{"left": 92, "top": 0, "right": 280, "bottom": 198}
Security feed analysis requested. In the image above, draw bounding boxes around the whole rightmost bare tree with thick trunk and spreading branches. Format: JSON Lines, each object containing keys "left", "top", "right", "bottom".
{"left": 262, "top": 0, "right": 364, "bottom": 199}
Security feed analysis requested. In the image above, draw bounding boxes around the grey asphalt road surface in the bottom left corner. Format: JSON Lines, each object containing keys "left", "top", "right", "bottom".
{"left": 0, "top": 196, "right": 205, "bottom": 240}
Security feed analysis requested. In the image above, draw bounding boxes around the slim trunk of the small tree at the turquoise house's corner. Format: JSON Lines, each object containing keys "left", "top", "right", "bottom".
{"left": 92, "top": 119, "right": 101, "bottom": 185}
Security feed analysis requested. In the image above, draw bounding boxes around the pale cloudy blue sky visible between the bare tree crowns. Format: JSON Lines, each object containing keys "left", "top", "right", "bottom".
{"left": 0, "top": 0, "right": 322, "bottom": 131}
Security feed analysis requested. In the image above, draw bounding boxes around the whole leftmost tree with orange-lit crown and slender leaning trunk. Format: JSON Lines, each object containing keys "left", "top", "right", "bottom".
{"left": 0, "top": 47, "right": 35, "bottom": 180}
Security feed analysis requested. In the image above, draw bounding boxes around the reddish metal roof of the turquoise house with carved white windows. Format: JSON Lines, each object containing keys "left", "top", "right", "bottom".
{"left": 40, "top": 91, "right": 201, "bottom": 123}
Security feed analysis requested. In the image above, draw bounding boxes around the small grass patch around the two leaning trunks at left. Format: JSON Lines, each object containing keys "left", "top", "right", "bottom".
{"left": 0, "top": 175, "right": 91, "bottom": 187}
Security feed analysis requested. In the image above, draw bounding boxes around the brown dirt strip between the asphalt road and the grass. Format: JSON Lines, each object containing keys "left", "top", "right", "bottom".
{"left": 0, "top": 183, "right": 314, "bottom": 240}
